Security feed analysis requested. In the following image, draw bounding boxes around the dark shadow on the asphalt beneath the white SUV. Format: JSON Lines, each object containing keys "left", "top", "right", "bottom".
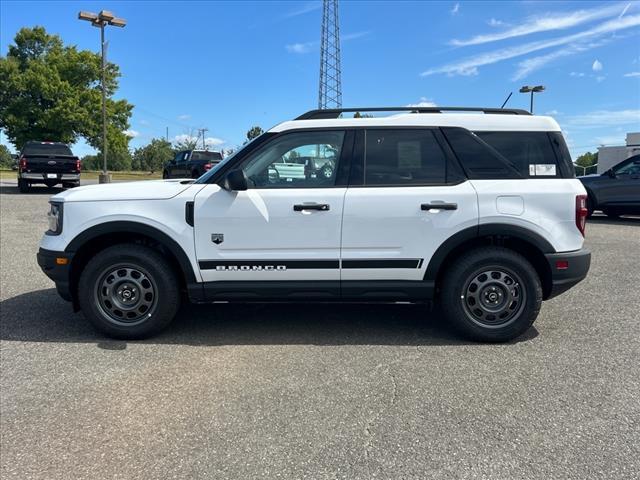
{"left": 0, "top": 289, "right": 538, "bottom": 350}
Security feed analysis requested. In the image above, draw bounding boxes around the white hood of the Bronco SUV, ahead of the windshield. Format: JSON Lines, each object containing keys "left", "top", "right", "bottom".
{"left": 51, "top": 179, "right": 193, "bottom": 202}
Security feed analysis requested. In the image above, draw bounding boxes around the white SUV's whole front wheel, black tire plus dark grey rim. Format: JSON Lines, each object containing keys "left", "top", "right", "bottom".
{"left": 78, "top": 243, "right": 180, "bottom": 340}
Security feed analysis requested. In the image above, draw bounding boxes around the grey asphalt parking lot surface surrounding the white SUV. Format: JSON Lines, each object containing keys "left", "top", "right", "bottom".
{"left": 0, "top": 181, "right": 640, "bottom": 479}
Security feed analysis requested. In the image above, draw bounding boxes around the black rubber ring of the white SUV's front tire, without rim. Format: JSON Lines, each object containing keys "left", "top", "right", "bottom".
{"left": 78, "top": 245, "right": 180, "bottom": 339}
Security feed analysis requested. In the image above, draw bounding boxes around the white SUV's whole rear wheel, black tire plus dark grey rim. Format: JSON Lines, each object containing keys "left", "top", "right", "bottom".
{"left": 440, "top": 247, "right": 542, "bottom": 342}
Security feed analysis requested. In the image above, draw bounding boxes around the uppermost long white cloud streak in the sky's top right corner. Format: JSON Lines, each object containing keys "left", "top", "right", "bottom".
{"left": 449, "top": 3, "right": 631, "bottom": 47}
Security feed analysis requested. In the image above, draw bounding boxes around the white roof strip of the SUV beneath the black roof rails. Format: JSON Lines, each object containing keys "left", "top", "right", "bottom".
{"left": 269, "top": 113, "right": 560, "bottom": 132}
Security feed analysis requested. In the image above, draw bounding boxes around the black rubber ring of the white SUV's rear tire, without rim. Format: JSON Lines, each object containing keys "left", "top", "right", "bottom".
{"left": 441, "top": 248, "right": 542, "bottom": 342}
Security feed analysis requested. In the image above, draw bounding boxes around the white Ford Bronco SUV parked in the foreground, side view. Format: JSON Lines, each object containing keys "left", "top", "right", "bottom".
{"left": 38, "top": 107, "right": 590, "bottom": 341}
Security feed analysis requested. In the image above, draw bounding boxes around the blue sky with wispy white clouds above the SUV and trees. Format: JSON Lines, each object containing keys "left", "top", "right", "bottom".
{"left": 0, "top": 0, "right": 640, "bottom": 159}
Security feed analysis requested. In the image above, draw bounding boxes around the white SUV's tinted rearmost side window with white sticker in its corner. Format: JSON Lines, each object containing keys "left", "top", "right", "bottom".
{"left": 475, "top": 132, "right": 562, "bottom": 178}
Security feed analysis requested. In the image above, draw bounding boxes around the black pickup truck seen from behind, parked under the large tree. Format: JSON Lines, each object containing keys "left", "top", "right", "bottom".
{"left": 18, "top": 141, "right": 82, "bottom": 193}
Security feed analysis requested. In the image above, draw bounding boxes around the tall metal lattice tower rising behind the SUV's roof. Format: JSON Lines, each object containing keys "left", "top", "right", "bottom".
{"left": 318, "top": 0, "right": 342, "bottom": 109}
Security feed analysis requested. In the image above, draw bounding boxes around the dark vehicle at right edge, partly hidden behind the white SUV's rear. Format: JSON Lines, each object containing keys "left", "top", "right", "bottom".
{"left": 578, "top": 155, "right": 640, "bottom": 218}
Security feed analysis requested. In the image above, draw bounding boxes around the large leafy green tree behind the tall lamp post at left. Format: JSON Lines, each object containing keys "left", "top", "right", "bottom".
{"left": 0, "top": 27, "right": 133, "bottom": 158}
